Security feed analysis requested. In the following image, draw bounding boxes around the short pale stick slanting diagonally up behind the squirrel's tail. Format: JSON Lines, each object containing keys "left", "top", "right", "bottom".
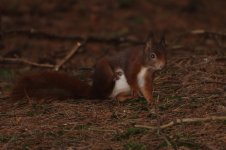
{"left": 54, "top": 42, "right": 82, "bottom": 71}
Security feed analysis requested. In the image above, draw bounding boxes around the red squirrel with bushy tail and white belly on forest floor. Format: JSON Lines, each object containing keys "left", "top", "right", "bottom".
{"left": 11, "top": 34, "right": 166, "bottom": 103}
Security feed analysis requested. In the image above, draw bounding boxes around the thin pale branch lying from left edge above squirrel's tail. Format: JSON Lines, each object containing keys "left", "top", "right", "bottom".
{"left": 0, "top": 56, "right": 54, "bottom": 68}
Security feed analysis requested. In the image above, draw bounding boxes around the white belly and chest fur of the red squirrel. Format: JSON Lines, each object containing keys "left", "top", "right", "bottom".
{"left": 111, "top": 67, "right": 148, "bottom": 97}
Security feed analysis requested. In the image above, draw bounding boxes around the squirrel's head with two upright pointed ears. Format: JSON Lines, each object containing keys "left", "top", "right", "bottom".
{"left": 144, "top": 33, "right": 166, "bottom": 70}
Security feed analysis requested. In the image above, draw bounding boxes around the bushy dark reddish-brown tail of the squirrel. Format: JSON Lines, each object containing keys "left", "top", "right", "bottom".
{"left": 11, "top": 72, "right": 91, "bottom": 101}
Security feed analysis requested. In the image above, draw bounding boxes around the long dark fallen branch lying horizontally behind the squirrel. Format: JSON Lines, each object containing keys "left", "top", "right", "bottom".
{"left": 2, "top": 29, "right": 144, "bottom": 45}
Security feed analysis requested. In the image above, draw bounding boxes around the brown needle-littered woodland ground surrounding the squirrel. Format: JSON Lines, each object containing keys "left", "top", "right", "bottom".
{"left": 0, "top": 0, "right": 226, "bottom": 150}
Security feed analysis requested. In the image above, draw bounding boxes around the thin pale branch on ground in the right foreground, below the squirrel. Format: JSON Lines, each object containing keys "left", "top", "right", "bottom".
{"left": 135, "top": 116, "right": 226, "bottom": 130}
